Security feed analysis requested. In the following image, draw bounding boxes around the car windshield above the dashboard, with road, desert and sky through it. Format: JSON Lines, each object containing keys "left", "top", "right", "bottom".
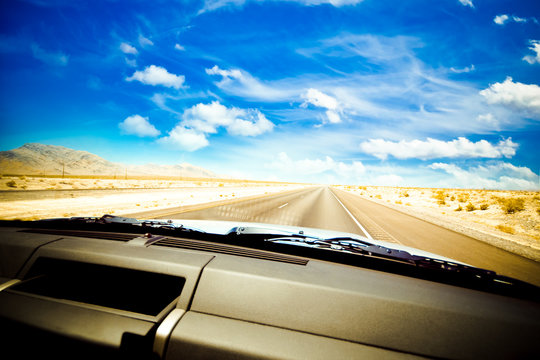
{"left": 0, "top": 0, "right": 540, "bottom": 285}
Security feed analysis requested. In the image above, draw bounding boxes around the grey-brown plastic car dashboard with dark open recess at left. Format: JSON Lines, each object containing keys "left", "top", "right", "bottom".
{"left": 0, "top": 226, "right": 540, "bottom": 359}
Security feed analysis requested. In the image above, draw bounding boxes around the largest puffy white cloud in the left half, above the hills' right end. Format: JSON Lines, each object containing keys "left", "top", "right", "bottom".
{"left": 158, "top": 102, "right": 274, "bottom": 151}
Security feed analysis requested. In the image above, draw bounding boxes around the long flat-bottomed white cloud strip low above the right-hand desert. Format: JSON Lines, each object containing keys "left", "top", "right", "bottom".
{"left": 360, "top": 137, "right": 518, "bottom": 160}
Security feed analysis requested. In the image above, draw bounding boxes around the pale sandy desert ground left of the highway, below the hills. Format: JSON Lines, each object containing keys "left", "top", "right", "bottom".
{"left": 0, "top": 176, "right": 304, "bottom": 220}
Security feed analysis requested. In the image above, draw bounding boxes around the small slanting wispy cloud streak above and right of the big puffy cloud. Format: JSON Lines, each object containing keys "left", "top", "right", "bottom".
{"left": 206, "top": 65, "right": 297, "bottom": 101}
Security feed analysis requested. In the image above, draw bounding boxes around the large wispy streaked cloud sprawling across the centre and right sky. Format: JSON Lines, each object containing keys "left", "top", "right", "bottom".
{"left": 199, "top": 33, "right": 526, "bottom": 136}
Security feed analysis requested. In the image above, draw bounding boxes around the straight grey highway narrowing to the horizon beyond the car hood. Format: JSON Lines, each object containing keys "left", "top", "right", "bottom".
{"left": 133, "top": 187, "right": 540, "bottom": 286}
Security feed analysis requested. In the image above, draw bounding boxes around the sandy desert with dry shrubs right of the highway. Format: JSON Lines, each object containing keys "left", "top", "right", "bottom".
{"left": 336, "top": 186, "right": 540, "bottom": 261}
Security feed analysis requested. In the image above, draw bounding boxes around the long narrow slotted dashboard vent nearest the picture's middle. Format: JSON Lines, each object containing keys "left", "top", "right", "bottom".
{"left": 152, "top": 238, "right": 309, "bottom": 266}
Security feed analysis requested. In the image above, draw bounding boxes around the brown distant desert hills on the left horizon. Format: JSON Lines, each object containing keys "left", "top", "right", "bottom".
{"left": 0, "top": 143, "right": 217, "bottom": 178}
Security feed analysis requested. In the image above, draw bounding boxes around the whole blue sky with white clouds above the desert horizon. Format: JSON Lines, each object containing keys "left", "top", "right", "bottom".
{"left": 0, "top": 0, "right": 540, "bottom": 189}
